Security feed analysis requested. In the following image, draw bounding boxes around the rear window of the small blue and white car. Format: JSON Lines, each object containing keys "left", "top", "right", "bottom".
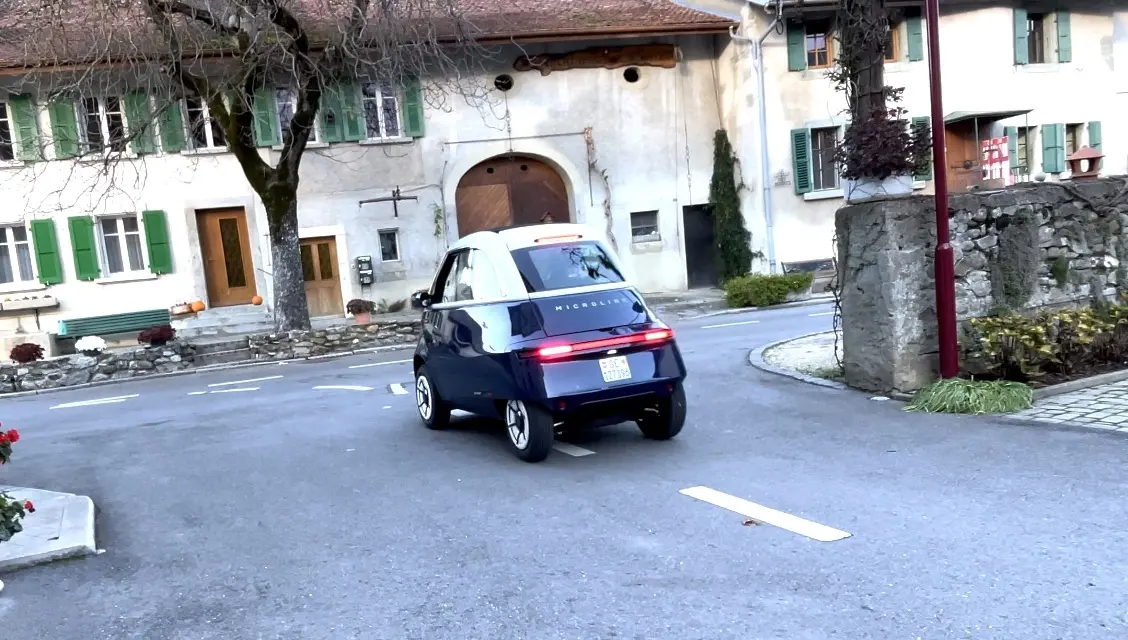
{"left": 511, "top": 242, "right": 624, "bottom": 293}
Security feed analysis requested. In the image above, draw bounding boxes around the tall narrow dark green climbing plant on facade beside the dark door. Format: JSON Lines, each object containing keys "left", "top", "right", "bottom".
{"left": 708, "top": 130, "right": 755, "bottom": 282}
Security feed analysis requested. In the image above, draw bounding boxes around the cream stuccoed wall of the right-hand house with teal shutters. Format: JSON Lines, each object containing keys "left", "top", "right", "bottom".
{"left": 712, "top": 0, "right": 1128, "bottom": 270}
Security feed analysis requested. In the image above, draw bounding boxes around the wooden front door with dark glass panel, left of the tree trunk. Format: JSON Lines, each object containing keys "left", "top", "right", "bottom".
{"left": 196, "top": 209, "right": 257, "bottom": 307}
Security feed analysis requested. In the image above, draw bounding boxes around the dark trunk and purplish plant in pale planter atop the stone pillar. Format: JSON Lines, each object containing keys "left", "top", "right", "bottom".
{"left": 828, "top": 0, "right": 932, "bottom": 201}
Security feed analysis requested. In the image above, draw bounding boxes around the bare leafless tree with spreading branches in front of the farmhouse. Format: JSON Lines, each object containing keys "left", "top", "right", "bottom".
{"left": 0, "top": 0, "right": 490, "bottom": 331}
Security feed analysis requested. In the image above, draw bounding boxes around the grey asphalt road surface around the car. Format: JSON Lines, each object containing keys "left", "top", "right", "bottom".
{"left": 0, "top": 307, "right": 1128, "bottom": 640}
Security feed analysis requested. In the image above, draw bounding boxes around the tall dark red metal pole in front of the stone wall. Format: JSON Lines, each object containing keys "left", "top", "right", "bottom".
{"left": 925, "top": 0, "right": 960, "bottom": 378}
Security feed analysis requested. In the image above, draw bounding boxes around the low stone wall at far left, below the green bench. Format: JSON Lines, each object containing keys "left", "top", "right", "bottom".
{"left": 0, "top": 342, "right": 195, "bottom": 393}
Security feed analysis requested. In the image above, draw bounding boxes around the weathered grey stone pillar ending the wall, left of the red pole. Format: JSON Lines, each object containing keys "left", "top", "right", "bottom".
{"left": 835, "top": 195, "right": 937, "bottom": 393}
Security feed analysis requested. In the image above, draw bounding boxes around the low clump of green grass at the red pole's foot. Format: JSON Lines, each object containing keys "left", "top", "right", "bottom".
{"left": 905, "top": 378, "right": 1034, "bottom": 415}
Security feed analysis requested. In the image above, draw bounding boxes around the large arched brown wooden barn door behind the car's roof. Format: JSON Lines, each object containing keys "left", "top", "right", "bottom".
{"left": 455, "top": 156, "right": 572, "bottom": 237}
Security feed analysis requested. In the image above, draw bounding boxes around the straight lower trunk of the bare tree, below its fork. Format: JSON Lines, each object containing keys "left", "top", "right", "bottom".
{"left": 264, "top": 193, "right": 310, "bottom": 331}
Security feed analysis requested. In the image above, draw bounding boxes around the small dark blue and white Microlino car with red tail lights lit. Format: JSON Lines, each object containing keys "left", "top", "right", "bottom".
{"left": 415, "top": 223, "right": 686, "bottom": 462}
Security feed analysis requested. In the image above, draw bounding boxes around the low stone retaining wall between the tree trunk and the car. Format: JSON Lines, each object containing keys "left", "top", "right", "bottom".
{"left": 247, "top": 319, "right": 421, "bottom": 360}
